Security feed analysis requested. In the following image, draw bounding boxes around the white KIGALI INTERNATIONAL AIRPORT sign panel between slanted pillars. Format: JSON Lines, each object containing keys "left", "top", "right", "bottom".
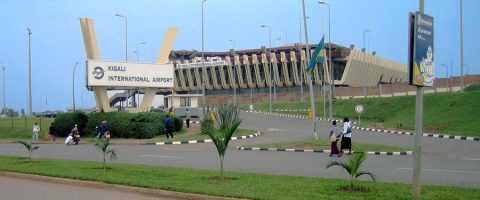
{"left": 87, "top": 60, "right": 174, "bottom": 88}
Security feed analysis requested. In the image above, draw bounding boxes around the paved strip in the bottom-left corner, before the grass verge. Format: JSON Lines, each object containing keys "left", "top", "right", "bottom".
{"left": 0, "top": 176, "right": 177, "bottom": 200}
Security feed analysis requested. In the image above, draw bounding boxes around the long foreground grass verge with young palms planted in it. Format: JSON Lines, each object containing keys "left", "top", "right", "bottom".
{"left": 0, "top": 156, "right": 480, "bottom": 200}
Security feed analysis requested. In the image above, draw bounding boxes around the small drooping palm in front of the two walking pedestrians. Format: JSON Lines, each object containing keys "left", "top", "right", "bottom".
{"left": 327, "top": 153, "right": 376, "bottom": 189}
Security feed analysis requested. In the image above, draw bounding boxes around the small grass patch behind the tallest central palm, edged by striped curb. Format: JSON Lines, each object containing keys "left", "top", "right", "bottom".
{"left": 150, "top": 128, "right": 257, "bottom": 142}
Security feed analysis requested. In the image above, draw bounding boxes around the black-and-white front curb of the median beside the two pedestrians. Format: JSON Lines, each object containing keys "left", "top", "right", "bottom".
{"left": 237, "top": 147, "right": 413, "bottom": 156}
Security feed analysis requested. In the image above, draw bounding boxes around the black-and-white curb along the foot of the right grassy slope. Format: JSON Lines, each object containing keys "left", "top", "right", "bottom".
{"left": 243, "top": 111, "right": 480, "bottom": 141}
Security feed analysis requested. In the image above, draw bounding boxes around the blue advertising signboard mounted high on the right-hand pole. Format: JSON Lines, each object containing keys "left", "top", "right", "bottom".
{"left": 408, "top": 12, "right": 435, "bottom": 87}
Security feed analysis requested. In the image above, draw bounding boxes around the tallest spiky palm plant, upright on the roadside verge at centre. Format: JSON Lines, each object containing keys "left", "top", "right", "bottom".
{"left": 201, "top": 104, "right": 242, "bottom": 180}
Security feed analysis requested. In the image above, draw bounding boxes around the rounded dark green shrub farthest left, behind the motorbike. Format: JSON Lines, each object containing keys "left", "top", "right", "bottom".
{"left": 53, "top": 111, "right": 88, "bottom": 136}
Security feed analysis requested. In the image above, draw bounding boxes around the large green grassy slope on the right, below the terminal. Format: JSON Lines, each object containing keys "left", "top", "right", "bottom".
{"left": 240, "top": 86, "right": 480, "bottom": 136}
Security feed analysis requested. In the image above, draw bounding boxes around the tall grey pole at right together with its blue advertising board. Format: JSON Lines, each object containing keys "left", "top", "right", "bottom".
{"left": 408, "top": 0, "right": 435, "bottom": 197}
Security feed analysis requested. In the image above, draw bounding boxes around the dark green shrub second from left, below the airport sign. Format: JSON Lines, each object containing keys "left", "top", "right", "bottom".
{"left": 86, "top": 112, "right": 132, "bottom": 138}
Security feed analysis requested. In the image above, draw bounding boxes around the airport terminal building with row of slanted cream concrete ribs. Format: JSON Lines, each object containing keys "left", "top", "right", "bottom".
{"left": 169, "top": 43, "right": 408, "bottom": 103}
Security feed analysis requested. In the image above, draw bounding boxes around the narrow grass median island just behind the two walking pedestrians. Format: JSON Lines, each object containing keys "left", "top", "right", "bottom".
{"left": 247, "top": 140, "right": 411, "bottom": 152}
